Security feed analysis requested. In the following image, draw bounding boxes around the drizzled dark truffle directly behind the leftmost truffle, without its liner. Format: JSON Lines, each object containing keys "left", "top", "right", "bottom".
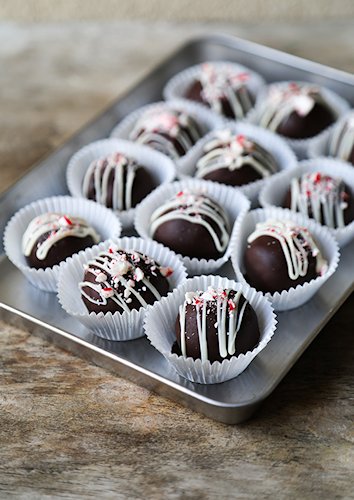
{"left": 82, "top": 153, "right": 155, "bottom": 211}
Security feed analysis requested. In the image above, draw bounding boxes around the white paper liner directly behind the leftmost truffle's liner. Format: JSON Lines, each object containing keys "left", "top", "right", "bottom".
{"left": 66, "top": 139, "right": 176, "bottom": 228}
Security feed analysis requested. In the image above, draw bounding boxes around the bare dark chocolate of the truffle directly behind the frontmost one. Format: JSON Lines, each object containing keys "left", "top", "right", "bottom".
{"left": 244, "top": 236, "right": 318, "bottom": 293}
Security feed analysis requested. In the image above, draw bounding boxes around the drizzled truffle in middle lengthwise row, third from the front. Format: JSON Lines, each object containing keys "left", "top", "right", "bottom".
{"left": 196, "top": 129, "right": 278, "bottom": 186}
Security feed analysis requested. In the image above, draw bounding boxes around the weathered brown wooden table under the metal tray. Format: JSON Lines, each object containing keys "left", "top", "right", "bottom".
{"left": 0, "top": 20, "right": 354, "bottom": 499}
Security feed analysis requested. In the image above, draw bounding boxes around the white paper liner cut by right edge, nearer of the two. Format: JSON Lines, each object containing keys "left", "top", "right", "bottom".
{"left": 259, "top": 158, "right": 354, "bottom": 247}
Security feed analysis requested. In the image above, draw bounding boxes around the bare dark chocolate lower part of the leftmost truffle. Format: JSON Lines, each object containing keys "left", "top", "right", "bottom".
{"left": 26, "top": 233, "right": 95, "bottom": 269}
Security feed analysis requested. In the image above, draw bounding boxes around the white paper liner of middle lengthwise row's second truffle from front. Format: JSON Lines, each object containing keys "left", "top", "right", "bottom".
{"left": 134, "top": 179, "right": 250, "bottom": 275}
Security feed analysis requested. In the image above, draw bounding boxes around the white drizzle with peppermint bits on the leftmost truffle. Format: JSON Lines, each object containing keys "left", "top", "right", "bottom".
{"left": 22, "top": 212, "right": 100, "bottom": 260}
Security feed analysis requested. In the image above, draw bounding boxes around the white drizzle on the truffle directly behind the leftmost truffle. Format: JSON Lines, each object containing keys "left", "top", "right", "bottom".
{"left": 82, "top": 153, "right": 139, "bottom": 211}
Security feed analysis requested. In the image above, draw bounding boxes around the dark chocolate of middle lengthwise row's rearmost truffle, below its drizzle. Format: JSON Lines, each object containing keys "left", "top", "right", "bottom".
{"left": 276, "top": 102, "right": 336, "bottom": 139}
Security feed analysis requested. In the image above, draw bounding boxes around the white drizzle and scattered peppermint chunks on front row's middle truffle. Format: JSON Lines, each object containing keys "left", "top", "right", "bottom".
{"left": 79, "top": 246, "right": 173, "bottom": 312}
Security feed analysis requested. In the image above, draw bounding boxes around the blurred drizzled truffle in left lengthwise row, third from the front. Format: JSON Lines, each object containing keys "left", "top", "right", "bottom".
{"left": 129, "top": 107, "right": 202, "bottom": 160}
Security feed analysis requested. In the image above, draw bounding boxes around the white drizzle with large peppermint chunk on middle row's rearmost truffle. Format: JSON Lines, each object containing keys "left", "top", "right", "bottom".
{"left": 259, "top": 82, "right": 334, "bottom": 132}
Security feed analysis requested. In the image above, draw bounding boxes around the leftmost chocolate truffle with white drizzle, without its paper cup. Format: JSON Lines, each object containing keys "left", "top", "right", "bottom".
{"left": 22, "top": 213, "right": 99, "bottom": 269}
